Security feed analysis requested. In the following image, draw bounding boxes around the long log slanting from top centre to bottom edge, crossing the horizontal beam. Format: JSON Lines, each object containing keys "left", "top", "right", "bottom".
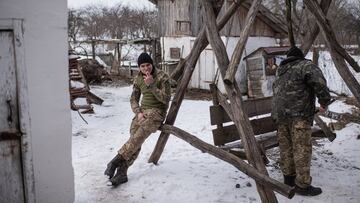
{"left": 201, "top": 0, "right": 278, "bottom": 203}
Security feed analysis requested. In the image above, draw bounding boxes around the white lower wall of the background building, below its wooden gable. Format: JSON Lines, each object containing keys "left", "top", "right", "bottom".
{"left": 161, "top": 37, "right": 276, "bottom": 91}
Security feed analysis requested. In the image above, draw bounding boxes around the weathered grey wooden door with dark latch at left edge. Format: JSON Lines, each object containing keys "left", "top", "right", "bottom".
{"left": 0, "top": 29, "right": 25, "bottom": 202}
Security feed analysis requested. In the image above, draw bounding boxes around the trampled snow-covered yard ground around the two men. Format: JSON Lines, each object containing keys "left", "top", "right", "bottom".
{"left": 72, "top": 86, "right": 360, "bottom": 203}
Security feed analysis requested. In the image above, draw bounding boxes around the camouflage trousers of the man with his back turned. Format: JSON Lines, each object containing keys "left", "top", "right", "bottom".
{"left": 277, "top": 119, "right": 312, "bottom": 188}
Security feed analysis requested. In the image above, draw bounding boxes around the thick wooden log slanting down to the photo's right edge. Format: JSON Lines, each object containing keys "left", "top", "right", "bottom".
{"left": 304, "top": 0, "right": 360, "bottom": 103}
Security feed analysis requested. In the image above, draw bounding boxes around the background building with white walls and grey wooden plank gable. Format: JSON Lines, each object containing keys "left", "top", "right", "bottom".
{"left": 151, "top": 0, "right": 287, "bottom": 94}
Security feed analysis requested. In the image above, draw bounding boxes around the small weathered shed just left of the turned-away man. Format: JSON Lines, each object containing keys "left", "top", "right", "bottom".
{"left": 243, "top": 46, "right": 289, "bottom": 98}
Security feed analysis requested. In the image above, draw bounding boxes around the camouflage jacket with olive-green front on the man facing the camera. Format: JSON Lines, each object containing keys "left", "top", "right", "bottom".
{"left": 130, "top": 68, "right": 171, "bottom": 116}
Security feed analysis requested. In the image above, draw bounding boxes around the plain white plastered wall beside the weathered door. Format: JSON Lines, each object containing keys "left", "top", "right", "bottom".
{"left": 0, "top": 0, "right": 74, "bottom": 203}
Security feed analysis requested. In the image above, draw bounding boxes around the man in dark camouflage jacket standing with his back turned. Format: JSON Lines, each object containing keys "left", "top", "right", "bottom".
{"left": 272, "top": 47, "right": 330, "bottom": 196}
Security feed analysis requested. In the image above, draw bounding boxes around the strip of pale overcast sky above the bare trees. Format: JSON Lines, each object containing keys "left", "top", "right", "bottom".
{"left": 68, "top": 0, "right": 155, "bottom": 8}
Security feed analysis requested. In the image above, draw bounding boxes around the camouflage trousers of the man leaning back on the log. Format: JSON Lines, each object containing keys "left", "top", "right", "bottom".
{"left": 118, "top": 109, "right": 165, "bottom": 166}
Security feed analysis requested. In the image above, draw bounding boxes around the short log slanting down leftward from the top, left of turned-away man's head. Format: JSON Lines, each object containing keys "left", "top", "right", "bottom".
{"left": 224, "top": 0, "right": 262, "bottom": 84}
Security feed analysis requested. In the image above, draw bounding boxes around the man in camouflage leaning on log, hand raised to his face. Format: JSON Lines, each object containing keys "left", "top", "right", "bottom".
{"left": 105, "top": 53, "right": 171, "bottom": 186}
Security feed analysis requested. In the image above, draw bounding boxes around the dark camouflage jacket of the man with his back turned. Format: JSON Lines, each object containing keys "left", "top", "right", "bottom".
{"left": 271, "top": 57, "right": 330, "bottom": 123}
